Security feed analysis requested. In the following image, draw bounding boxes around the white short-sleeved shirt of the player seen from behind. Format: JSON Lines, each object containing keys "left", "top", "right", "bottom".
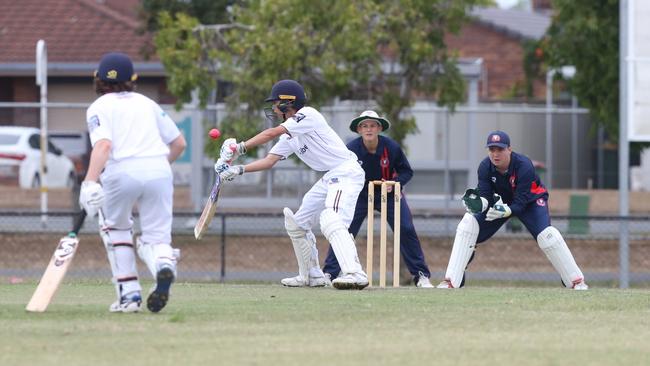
{"left": 86, "top": 92, "right": 180, "bottom": 164}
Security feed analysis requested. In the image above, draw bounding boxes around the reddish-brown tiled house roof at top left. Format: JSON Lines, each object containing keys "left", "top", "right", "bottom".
{"left": 0, "top": 0, "right": 163, "bottom": 75}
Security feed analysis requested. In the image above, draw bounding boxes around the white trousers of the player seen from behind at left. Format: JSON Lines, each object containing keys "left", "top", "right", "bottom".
{"left": 101, "top": 156, "right": 174, "bottom": 244}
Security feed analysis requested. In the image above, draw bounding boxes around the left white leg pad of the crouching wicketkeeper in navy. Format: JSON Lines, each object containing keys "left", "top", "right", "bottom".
{"left": 445, "top": 213, "right": 479, "bottom": 288}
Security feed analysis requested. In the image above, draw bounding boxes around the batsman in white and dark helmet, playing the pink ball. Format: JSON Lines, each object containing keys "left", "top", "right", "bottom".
{"left": 215, "top": 80, "right": 368, "bottom": 289}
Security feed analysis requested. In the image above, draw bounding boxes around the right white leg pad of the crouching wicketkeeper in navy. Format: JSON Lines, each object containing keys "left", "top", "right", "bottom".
{"left": 537, "top": 226, "right": 584, "bottom": 288}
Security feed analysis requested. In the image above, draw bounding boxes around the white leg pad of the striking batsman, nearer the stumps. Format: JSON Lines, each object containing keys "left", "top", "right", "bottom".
{"left": 320, "top": 208, "right": 365, "bottom": 275}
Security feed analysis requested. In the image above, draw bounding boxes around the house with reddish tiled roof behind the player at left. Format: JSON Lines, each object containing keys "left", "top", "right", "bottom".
{"left": 0, "top": 0, "right": 168, "bottom": 130}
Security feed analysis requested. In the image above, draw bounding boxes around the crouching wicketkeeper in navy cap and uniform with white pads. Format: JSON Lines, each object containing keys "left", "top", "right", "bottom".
{"left": 438, "top": 131, "right": 589, "bottom": 290}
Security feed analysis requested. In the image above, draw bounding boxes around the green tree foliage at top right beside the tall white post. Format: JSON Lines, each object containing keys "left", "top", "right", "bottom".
{"left": 543, "top": 0, "right": 619, "bottom": 141}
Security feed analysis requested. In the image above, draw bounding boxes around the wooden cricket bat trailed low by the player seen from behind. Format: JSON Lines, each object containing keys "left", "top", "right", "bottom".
{"left": 25, "top": 210, "right": 86, "bottom": 313}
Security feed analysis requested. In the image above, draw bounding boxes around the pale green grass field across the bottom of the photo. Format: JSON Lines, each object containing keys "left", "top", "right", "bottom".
{"left": 0, "top": 282, "right": 650, "bottom": 366}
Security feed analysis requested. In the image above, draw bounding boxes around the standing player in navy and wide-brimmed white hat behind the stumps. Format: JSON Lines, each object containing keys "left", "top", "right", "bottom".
{"left": 323, "top": 111, "right": 433, "bottom": 288}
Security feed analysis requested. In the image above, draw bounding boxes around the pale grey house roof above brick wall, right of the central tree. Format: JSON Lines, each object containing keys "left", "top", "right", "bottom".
{"left": 471, "top": 8, "right": 551, "bottom": 40}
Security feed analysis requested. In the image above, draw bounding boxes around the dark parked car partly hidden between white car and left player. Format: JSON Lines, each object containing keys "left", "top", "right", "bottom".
{"left": 48, "top": 131, "right": 92, "bottom": 183}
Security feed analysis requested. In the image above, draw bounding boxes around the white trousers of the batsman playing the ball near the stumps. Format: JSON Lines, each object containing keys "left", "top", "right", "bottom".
{"left": 294, "top": 159, "right": 366, "bottom": 230}
